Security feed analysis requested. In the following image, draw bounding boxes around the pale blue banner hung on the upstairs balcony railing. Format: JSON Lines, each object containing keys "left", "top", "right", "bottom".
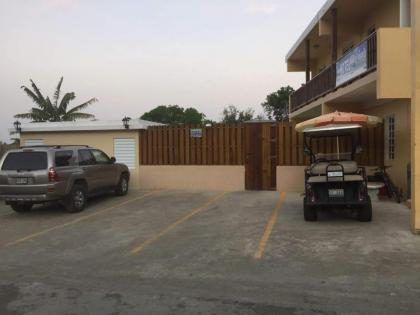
{"left": 336, "top": 42, "right": 368, "bottom": 86}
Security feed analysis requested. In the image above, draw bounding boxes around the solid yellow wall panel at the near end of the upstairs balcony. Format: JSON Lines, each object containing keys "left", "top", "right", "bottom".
{"left": 376, "top": 28, "right": 411, "bottom": 99}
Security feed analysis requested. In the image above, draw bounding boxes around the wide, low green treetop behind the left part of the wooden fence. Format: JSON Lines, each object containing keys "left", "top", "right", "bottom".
{"left": 140, "top": 105, "right": 206, "bottom": 125}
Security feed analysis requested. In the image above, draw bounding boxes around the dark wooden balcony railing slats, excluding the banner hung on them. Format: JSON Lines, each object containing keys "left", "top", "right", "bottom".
{"left": 290, "top": 33, "right": 377, "bottom": 113}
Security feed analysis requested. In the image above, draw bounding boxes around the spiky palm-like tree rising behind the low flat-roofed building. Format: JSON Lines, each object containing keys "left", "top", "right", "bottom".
{"left": 15, "top": 77, "right": 98, "bottom": 122}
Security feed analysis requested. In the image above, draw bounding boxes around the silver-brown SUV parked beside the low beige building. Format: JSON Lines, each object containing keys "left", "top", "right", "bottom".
{"left": 0, "top": 145, "right": 130, "bottom": 212}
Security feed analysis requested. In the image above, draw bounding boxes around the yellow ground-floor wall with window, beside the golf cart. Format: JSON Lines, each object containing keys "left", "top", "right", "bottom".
{"left": 362, "top": 100, "right": 411, "bottom": 197}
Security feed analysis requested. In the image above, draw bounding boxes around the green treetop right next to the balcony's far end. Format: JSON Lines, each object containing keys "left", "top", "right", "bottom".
{"left": 261, "top": 86, "right": 295, "bottom": 121}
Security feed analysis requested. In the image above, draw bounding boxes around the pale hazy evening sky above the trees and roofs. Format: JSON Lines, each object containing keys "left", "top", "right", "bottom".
{"left": 0, "top": 0, "right": 325, "bottom": 141}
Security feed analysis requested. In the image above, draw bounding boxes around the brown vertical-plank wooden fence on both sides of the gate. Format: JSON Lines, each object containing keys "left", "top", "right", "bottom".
{"left": 139, "top": 123, "right": 384, "bottom": 166}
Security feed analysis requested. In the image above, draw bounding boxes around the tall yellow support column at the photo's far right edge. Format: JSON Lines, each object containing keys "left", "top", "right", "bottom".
{"left": 411, "top": 0, "right": 420, "bottom": 233}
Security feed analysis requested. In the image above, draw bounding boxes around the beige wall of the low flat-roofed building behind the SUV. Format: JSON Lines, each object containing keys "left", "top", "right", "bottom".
{"left": 20, "top": 130, "right": 140, "bottom": 189}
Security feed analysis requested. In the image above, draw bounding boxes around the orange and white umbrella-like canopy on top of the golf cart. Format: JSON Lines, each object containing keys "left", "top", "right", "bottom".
{"left": 296, "top": 112, "right": 382, "bottom": 133}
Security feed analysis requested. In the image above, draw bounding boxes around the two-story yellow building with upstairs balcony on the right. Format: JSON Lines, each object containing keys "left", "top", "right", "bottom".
{"left": 286, "top": 0, "right": 420, "bottom": 228}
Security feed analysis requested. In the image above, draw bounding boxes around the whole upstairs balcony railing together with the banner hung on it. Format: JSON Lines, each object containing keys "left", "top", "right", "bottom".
{"left": 290, "top": 33, "right": 377, "bottom": 112}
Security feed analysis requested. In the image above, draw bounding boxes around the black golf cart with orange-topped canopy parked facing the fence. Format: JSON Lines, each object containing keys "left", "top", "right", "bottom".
{"left": 296, "top": 113, "right": 382, "bottom": 222}
